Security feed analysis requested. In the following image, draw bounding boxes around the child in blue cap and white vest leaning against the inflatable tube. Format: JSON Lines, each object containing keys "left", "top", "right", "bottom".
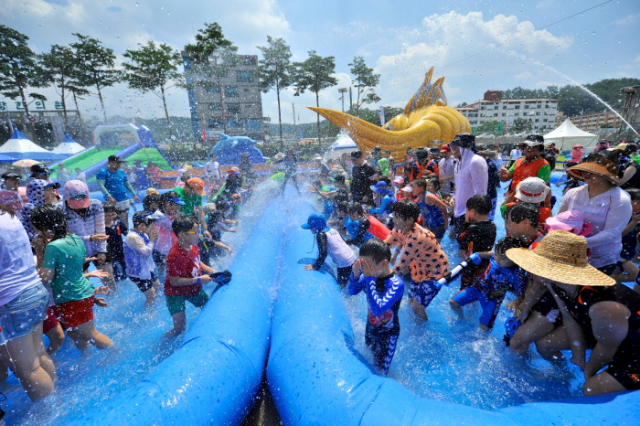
{"left": 302, "top": 213, "right": 357, "bottom": 288}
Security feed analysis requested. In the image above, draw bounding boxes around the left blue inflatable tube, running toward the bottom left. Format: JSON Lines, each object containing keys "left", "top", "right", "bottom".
{"left": 73, "top": 203, "right": 286, "bottom": 425}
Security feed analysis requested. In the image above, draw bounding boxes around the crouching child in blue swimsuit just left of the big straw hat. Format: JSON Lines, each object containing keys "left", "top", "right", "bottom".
{"left": 449, "top": 237, "right": 526, "bottom": 331}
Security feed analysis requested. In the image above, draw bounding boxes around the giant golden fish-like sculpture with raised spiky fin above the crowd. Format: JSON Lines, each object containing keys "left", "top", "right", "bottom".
{"left": 307, "top": 68, "right": 471, "bottom": 161}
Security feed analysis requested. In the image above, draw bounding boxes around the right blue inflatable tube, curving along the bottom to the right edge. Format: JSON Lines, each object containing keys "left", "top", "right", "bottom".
{"left": 267, "top": 200, "right": 640, "bottom": 426}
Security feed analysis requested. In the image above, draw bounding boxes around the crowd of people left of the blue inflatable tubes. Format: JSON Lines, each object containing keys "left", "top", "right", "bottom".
{"left": 0, "top": 155, "right": 238, "bottom": 400}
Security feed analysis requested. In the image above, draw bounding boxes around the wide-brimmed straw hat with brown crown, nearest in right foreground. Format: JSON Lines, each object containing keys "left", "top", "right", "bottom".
{"left": 506, "top": 231, "right": 616, "bottom": 286}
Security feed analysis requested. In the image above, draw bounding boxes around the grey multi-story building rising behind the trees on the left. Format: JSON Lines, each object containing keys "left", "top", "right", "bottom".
{"left": 182, "top": 51, "right": 267, "bottom": 140}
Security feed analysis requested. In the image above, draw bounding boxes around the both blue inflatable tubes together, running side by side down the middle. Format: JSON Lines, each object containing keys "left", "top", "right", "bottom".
{"left": 53, "top": 181, "right": 640, "bottom": 426}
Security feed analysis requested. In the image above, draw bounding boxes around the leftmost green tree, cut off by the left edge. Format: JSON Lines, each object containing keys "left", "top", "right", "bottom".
{"left": 0, "top": 25, "right": 52, "bottom": 142}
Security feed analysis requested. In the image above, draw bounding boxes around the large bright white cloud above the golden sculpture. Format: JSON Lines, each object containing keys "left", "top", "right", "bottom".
{"left": 375, "top": 12, "right": 572, "bottom": 108}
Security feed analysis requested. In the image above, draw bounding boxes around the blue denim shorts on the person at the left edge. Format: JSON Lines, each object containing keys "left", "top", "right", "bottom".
{"left": 0, "top": 284, "right": 49, "bottom": 344}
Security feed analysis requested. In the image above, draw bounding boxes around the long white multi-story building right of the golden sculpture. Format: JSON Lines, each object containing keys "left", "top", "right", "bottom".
{"left": 456, "top": 90, "right": 558, "bottom": 132}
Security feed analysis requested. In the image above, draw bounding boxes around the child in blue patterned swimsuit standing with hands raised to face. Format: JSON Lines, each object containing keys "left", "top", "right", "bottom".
{"left": 347, "top": 238, "right": 404, "bottom": 375}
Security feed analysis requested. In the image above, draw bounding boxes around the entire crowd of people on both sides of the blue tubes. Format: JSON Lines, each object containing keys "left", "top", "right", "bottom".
{"left": 0, "top": 133, "right": 640, "bottom": 410}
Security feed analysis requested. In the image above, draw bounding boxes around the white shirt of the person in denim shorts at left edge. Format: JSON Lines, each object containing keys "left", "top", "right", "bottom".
{"left": 0, "top": 213, "right": 41, "bottom": 306}
